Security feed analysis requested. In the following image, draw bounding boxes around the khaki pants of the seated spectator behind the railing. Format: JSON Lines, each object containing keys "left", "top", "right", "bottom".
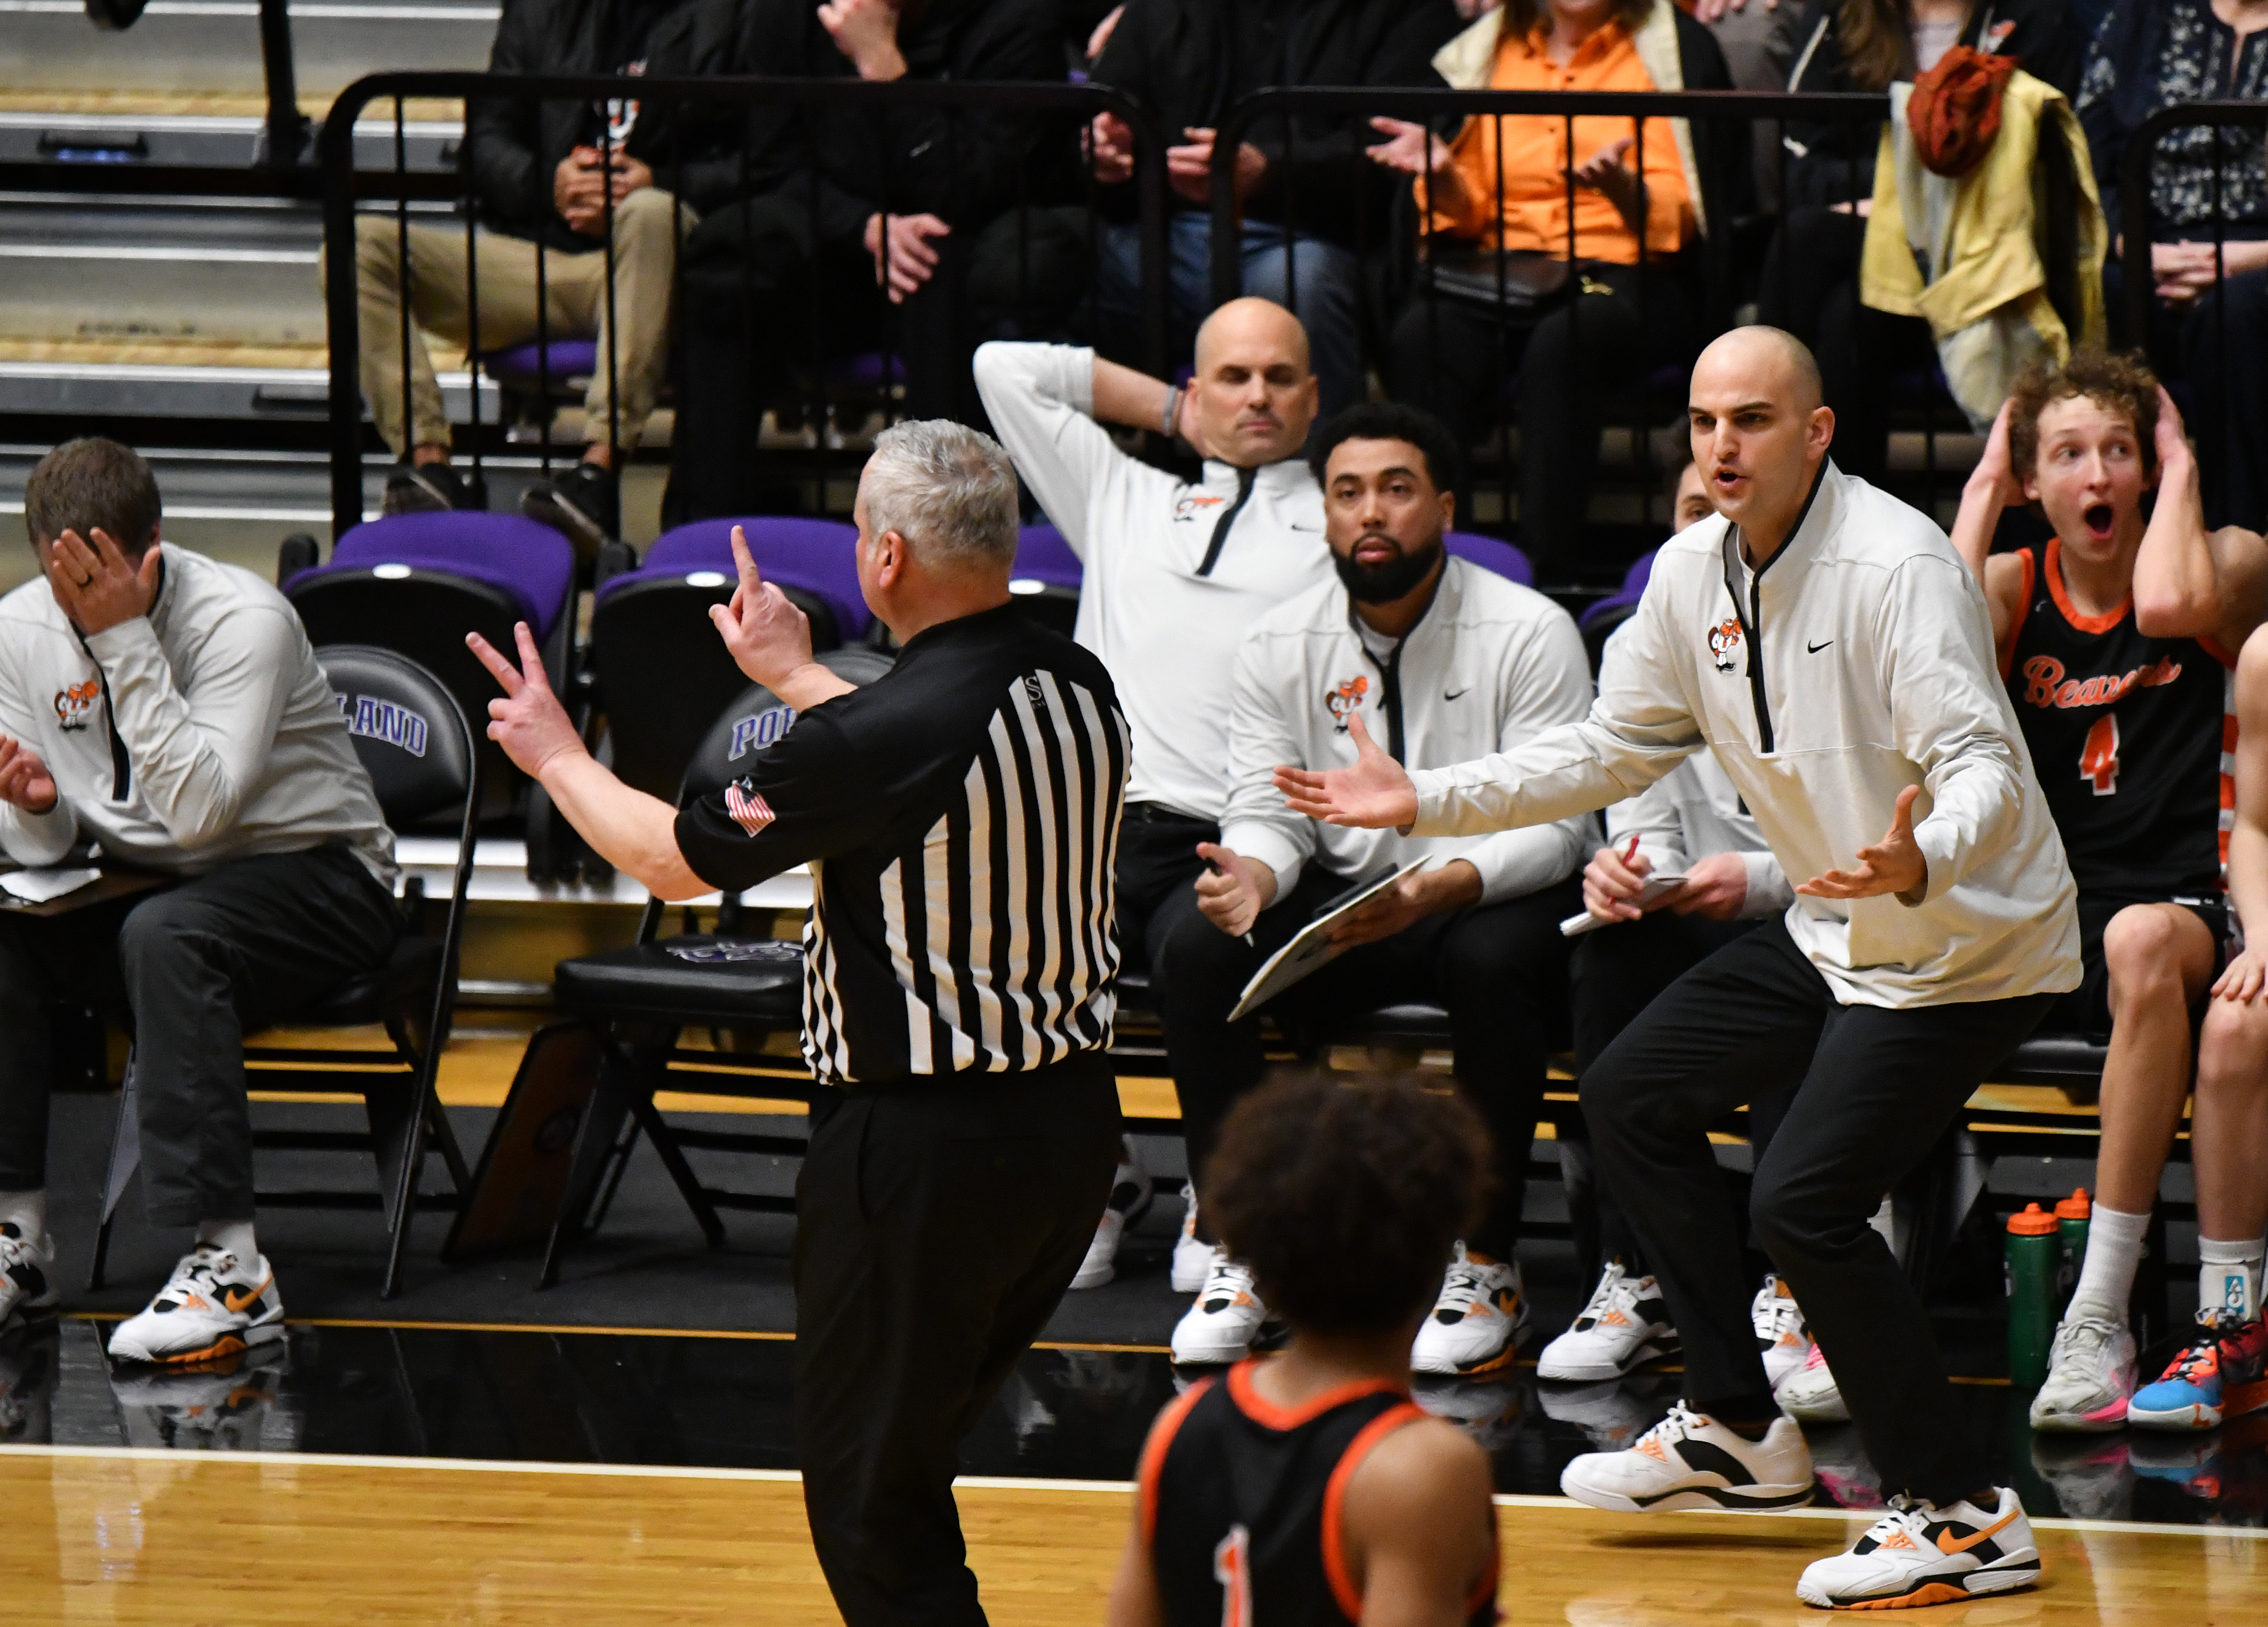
{"left": 354, "top": 186, "right": 699, "bottom": 456}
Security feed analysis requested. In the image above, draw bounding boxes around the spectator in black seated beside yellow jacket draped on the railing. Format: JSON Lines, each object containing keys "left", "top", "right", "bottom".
{"left": 1756, "top": 0, "right": 2084, "bottom": 481}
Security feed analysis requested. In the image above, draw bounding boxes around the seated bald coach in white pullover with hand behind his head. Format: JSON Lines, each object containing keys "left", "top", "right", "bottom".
{"left": 975, "top": 300, "right": 1331, "bottom": 998}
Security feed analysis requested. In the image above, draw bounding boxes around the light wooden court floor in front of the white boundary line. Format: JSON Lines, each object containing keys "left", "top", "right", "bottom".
{"left": 0, "top": 1448, "right": 2268, "bottom": 1627}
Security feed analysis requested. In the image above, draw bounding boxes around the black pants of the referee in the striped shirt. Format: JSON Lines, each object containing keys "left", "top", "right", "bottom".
{"left": 796, "top": 1053, "right": 1118, "bottom": 1627}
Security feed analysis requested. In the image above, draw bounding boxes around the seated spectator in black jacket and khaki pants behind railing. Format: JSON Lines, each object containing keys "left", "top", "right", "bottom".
{"left": 354, "top": 0, "right": 692, "bottom": 549}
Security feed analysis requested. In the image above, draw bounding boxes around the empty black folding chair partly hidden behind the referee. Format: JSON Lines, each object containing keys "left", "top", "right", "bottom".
{"left": 535, "top": 649, "right": 889, "bottom": 1289}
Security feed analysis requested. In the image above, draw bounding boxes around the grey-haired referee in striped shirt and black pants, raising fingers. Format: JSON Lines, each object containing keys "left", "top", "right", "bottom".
{"left": 469, "top": 422, "right": 1129, "bottom": 1627}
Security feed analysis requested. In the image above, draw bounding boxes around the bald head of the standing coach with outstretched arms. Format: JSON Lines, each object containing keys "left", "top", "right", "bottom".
{"left": 1685, "top": 327, "right": 1835, "bottom": 547}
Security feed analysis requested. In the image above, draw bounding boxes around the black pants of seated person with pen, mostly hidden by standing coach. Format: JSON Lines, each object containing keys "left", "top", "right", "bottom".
{"left": 1560, "top": 910, "right": 1769, "bottom": 1282}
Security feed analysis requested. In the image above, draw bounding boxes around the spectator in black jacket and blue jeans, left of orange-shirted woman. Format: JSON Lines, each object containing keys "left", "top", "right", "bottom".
{"left": 1093, "top": 0, "right": 1459, "bottom": 422}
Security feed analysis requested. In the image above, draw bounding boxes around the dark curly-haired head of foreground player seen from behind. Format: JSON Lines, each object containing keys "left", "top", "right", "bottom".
{"left": 1202, "top": 1073, "right": 1490, "bottom": 1343}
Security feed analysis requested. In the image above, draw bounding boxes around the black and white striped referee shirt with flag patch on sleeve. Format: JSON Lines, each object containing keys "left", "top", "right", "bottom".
{"left": 678, "top": 606, "right": 1129, "bottom": 1084}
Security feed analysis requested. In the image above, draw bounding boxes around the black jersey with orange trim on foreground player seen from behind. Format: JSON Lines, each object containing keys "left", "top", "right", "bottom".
{"left": 1141, "top": 1362, "right": 1497, "bottom": 1627}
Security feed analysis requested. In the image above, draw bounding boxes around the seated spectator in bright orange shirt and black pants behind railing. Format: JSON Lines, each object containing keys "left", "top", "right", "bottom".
{"left": 1370, "top": 0, "right": 1733, "bottom": 572}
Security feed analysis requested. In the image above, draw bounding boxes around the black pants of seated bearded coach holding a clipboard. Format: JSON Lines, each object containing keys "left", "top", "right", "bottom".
{"left": 1164, "top": 865, "right": 1583, "bottom": 1259}
